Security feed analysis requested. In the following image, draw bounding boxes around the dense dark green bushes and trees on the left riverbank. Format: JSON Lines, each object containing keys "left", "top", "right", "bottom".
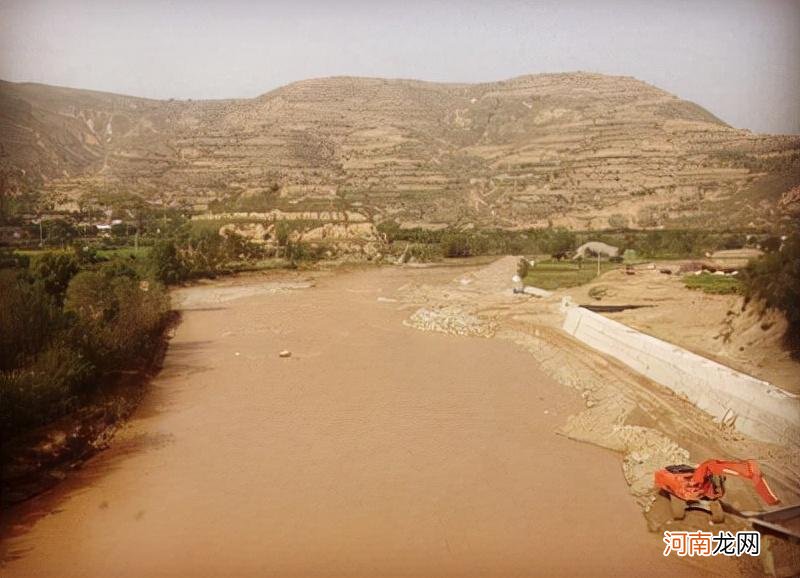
{"left": 0, "top": 244, "right": 169, "bottom": 439}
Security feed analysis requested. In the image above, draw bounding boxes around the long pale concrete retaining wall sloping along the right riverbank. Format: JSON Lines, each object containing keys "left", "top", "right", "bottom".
{"left": 563, "top": 306, "right": 800, "bottom": 446}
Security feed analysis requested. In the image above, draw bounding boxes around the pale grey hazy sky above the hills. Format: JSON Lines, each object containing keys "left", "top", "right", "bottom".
{"left": 0, "top": 0, "right": 800, "bottom": 133}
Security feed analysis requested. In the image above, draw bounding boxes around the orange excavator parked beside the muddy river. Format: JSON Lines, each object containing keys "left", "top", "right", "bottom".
{"left": 655, "top": 460, "right": 779, "bottom": 523}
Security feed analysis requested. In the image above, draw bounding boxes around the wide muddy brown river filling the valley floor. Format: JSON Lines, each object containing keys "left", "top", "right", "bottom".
{"left": 2, "top": 268, "right": 732, "bottom": 578}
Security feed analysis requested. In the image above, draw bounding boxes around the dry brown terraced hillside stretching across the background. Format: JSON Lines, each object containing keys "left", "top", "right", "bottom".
{"left": 0, "top": 73, "right": 800, "bottom": 228}
